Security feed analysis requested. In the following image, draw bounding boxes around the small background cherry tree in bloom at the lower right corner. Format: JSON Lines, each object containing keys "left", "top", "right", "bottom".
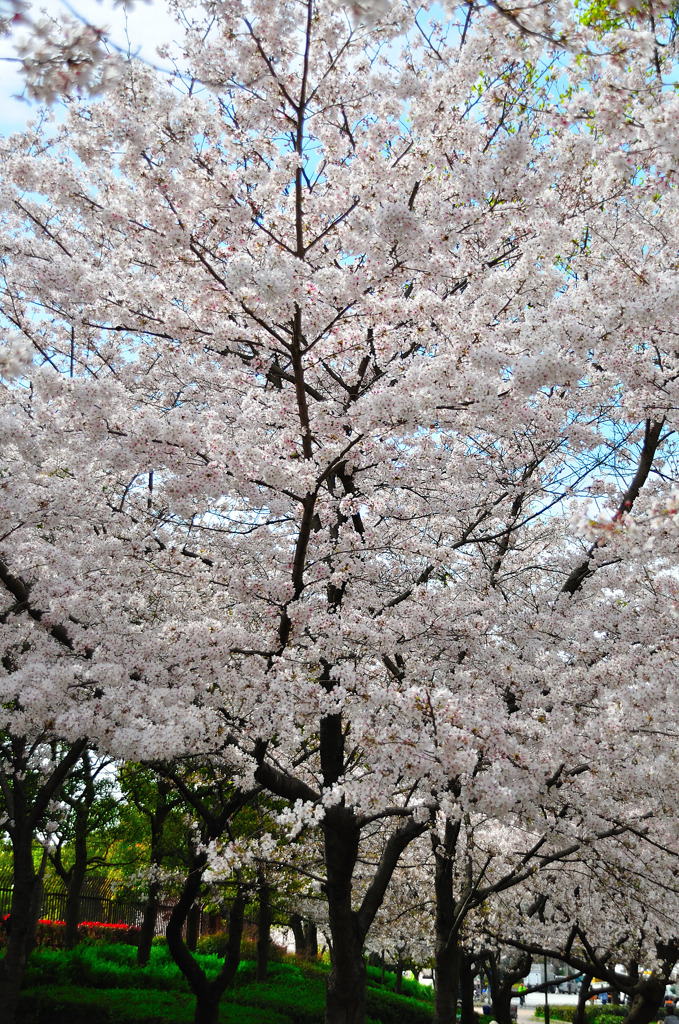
{"left": 486, "top": 822, "right": 679, "bottom": 1022}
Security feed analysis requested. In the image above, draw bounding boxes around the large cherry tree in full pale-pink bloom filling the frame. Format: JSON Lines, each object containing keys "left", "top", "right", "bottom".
{"left": 0, "top": 0, "right": 679, "bottom": 1024}
